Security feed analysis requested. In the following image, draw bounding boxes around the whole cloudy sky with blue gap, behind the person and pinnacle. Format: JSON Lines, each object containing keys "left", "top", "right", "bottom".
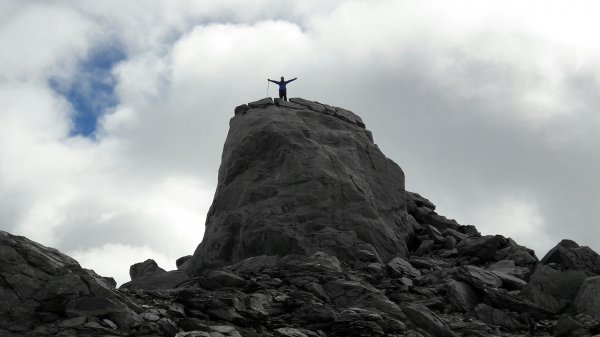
{"left": 0, "top": 0, "right": 600, "bottom": 283}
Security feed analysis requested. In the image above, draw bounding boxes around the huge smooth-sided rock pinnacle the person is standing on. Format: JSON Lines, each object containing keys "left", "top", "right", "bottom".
{"left": 186, "top": 99, "right": 414, "bottom": 273}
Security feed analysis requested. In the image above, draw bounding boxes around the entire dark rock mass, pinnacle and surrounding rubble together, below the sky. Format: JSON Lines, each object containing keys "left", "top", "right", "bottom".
{"left": 0, "top": 98, "right": 600, "bottom": 337}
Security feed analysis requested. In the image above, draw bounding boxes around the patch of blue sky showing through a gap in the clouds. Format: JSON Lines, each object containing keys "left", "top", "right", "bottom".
{"left": 50, "top": 46, "right": 126, "bottom": 138}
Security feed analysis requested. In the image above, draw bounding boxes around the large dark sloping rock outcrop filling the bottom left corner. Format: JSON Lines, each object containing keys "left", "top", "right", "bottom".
{"left": 0, "top": 231, "right": 141, "bottom": 336}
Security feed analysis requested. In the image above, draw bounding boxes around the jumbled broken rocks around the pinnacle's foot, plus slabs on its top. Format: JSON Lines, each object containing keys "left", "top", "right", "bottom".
{"left": 0, "top": 96, "right": 600, "bottom": 337}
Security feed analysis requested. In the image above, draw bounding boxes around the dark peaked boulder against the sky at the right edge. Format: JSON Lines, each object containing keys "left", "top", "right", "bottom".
{"left": 542, "top": 240, "right": 600, "bottom": 276}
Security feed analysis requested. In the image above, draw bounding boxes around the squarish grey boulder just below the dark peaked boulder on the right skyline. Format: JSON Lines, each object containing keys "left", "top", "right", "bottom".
{"left": 522, "top": 265, "right": 586, "bottom": 312}
